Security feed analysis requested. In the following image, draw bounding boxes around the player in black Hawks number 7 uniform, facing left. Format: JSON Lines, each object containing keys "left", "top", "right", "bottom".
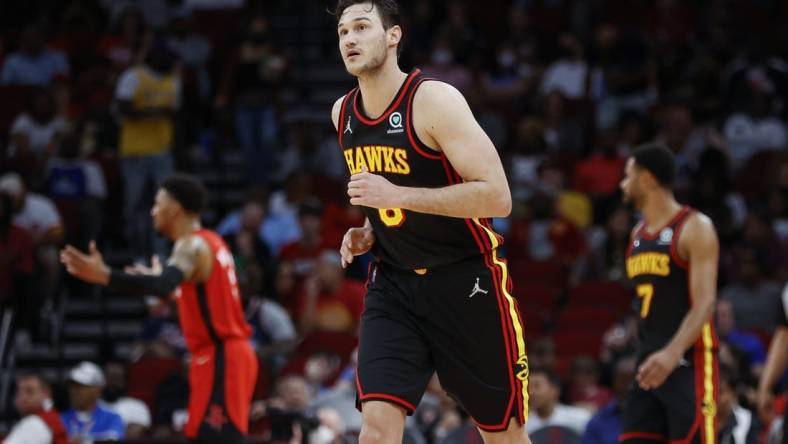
{"left": 619, "top": 145, "right": 719, "bottom": 444}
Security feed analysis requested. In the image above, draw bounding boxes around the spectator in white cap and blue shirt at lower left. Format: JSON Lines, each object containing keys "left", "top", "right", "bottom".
{"left": 61, "top": 361, "right": 126, "bottom": 442}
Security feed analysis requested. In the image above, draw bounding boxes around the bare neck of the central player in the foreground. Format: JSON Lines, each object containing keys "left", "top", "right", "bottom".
{"left": 358, "top": 61, "right": 408, "bottom": 119}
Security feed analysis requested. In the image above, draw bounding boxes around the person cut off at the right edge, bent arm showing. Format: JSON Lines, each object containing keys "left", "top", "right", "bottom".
{"left": 758, "top": 285, "right": 788, "bottom": 438}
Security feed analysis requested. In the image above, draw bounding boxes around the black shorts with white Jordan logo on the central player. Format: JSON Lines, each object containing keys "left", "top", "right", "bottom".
{"left": 356, "top": 252, "right": 528, "bottom": 431}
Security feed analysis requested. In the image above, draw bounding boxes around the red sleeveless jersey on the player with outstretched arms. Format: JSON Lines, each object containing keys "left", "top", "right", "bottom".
{"left": 175, "top": 229, "right": 252, "bottom": 352}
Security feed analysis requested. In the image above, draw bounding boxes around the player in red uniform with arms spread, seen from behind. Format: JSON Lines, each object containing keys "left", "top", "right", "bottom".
{"left": 60, "top": 175, "right": 257, "bottom": 444}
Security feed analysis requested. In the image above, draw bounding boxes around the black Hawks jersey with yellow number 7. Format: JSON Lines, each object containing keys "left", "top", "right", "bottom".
{"left": 626, "top": 207, "right": 716, "bottom": 358}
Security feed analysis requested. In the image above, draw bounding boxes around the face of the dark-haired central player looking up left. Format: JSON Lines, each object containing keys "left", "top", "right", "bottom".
{"left": 337, "top": 3, "right": 397, "bottom": 77}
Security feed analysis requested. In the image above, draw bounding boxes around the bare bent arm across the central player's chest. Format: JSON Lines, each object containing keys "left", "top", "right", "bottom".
{"left": 348, "top": 81, "right": 512, "bottom": 218}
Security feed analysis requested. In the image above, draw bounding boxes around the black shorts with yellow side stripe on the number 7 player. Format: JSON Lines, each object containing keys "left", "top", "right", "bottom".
{"left": 619, "top": 336, "right": 719, "bottom": 444}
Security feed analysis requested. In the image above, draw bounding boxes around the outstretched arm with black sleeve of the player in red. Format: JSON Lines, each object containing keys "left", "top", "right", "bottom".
{"left": 60, "top": 236, "right": 210, "bottom": 297}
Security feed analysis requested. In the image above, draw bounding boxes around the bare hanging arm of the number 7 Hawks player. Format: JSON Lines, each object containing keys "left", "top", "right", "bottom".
{"left": 637, "top": 214, "right": 720, "bottom": 390}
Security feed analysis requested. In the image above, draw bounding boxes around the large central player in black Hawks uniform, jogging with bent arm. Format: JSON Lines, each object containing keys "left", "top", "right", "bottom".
{"left": 332, "top": 0, "right": 529, "bottom": 444}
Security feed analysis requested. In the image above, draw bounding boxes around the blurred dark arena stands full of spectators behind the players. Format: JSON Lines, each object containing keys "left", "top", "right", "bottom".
{"left": 0, "top": 0, "right": 788, "bottom": 444}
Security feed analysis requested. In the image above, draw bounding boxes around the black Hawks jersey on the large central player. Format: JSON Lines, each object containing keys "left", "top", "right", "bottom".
{"left": 337, "top": 69, "right": 503, "bottom": 269}
